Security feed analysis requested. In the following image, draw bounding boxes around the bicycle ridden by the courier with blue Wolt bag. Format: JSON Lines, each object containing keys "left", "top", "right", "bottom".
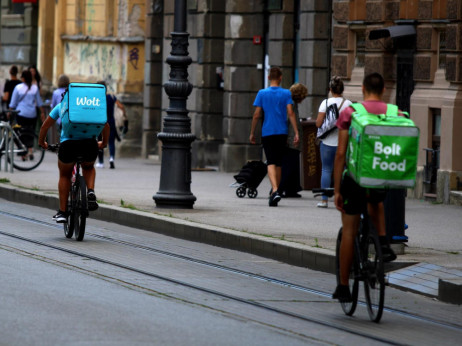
{"left": 48, "top": 144, "right": 89, "bottom": 241}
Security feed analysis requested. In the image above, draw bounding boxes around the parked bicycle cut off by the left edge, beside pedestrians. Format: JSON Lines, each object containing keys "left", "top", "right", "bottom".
{"left": 0, "top": 109, "right": 45, "bottom": 171}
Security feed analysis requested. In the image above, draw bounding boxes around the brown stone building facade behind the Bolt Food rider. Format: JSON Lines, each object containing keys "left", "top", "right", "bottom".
{"left": 332, "top": 0, "right": 462, "bottom": 203}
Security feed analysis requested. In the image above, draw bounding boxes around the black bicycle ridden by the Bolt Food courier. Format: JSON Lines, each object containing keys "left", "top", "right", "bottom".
{"left": 312, "top": 188, "right": 385, "bottom": 323}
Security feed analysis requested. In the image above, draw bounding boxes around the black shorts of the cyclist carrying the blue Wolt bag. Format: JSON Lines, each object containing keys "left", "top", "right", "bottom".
{"left": 58, "top": 138, "right": 98, "bottom": 163}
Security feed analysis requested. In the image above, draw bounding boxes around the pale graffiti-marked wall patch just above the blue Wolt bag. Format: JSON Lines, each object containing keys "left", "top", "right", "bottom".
{"left": 64, "top": 42, "right": 126, "bottom": 91}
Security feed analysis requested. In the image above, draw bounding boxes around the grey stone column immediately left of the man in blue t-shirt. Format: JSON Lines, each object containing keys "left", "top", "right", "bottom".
{"left": 220, "top": 1, "right": 264, "bottom": 172}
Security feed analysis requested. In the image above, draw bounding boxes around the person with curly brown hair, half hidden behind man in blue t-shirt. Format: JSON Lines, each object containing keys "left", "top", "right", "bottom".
{"left": 278, "top": 83, "right": 308, "bottom": 198}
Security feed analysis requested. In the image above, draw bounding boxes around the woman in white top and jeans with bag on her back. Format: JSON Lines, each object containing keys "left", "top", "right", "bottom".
{"left": 316, "top": 76, "right": 351, "bottom": 208}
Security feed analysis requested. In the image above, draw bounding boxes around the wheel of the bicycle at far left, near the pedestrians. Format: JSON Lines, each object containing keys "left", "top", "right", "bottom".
{"left": 9, "top": 129, "right": 45, "bottom": 171}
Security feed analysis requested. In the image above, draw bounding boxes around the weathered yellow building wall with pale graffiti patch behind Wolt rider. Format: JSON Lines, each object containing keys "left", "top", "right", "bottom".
{"left": 37, "top": 0, "right": 146, "bottom": 156}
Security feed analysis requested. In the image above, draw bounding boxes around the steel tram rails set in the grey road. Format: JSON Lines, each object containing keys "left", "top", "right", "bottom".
{"left": 0, "top": 211, "right": 462, "bottom": 345}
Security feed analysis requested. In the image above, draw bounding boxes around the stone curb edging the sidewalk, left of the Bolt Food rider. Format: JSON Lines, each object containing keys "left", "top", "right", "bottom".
{"left": 0, "top": 184, "right": 335, "bottom": 274}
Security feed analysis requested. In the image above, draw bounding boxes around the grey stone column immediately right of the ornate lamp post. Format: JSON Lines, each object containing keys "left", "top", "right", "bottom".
{"left": 188, "top": 0, "right": 225, "bottom": 168}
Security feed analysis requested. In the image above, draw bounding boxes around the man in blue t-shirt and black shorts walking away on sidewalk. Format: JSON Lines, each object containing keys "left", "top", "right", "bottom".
{"left": 250, "top": 67, "right": 299, "bottom": 207}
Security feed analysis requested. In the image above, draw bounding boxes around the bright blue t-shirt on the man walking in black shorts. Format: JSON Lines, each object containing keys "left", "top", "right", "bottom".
{"left": 253, "top": 87, "right": 294, "bottom": 137}
